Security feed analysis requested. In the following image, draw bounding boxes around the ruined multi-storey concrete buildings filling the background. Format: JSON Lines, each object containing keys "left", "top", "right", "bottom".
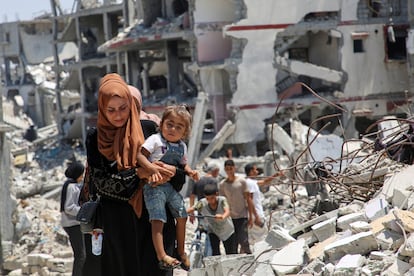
{"left": 0, "top": 0, "right": 413, "bottom": 159}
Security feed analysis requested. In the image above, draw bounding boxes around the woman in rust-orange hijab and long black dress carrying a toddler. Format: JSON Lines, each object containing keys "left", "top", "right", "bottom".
{"left": 82, "top": 73, "right": 183, "bottom": 276}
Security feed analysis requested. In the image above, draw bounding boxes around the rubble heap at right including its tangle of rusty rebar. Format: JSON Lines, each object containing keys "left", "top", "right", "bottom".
{"left": 190, "top": 118, "right": 414, "bottom": 276}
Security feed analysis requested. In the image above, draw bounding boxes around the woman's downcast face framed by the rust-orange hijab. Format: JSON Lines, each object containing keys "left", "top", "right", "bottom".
{"left": 104, "top": 97, "right": 130, "bottom": 127}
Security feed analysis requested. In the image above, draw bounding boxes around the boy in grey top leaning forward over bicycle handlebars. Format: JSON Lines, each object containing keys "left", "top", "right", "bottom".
{"left": 187, "top": 184, "right": 237, "bottom": 256}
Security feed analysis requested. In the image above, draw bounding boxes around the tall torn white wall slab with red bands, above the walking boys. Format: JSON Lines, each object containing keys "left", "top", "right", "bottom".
{"left": 224, "top": 0, "right": 341, "bottom": 144}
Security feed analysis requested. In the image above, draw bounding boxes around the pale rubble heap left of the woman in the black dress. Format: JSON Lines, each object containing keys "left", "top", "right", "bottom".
{"left": 2, "top": 121, "right": 86, "bottom": 275}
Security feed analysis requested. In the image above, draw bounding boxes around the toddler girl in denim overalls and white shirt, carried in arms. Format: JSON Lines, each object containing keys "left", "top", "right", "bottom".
{"left": 139, "top": 105, "right": 199, "bottom": 270}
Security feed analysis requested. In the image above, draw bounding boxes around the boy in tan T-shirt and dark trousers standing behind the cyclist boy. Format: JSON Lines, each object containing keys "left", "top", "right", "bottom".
{"left": 219, "top": 159, "right": 253, "bottom": 254}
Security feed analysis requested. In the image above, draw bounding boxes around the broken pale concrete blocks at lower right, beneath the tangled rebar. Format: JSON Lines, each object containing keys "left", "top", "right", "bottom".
{"left": 190, "top": 166, "right": 414, "bottom": 276}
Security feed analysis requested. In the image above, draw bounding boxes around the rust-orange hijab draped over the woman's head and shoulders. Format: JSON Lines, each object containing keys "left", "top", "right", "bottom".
{"left": 97, "top": 73, "right": 144, "bottom": 170}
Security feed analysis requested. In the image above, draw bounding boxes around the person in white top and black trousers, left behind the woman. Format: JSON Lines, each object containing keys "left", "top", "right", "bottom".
{"left": 60, "top": 161, "right": 86, "bottom": 276}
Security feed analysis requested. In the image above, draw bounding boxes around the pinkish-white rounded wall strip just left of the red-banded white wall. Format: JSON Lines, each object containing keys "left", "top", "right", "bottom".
{"left": 192, "top": 0, "right": 238, "bottom": 131}
